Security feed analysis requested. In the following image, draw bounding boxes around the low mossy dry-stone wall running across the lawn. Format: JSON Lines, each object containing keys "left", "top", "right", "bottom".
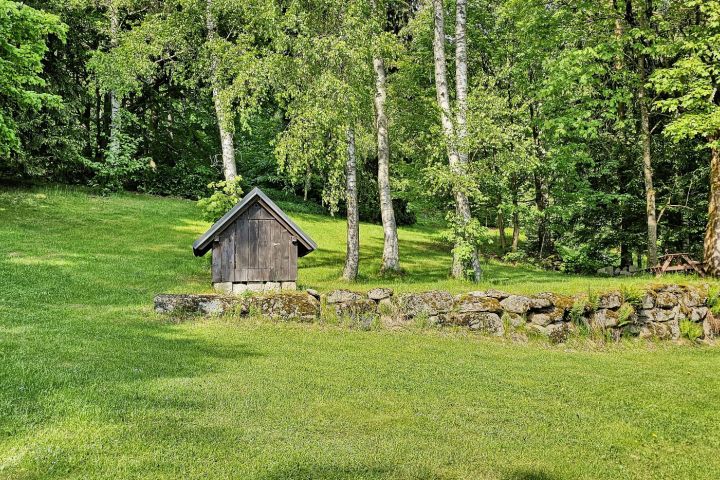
{"left": 155, "top": 285, "right": 720, "bottom": 341}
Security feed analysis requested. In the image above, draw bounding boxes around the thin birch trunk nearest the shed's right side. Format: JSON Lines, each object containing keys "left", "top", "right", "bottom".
{"left": 343, "top": 128, "right": 360, "bottom": 280}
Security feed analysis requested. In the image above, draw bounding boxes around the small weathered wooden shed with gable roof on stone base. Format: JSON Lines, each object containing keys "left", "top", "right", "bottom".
{"left": 193, "top": 188, "right": 317, "bottom": 293}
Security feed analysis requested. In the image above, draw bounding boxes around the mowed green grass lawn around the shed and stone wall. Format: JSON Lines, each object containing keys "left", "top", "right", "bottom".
{"left": 0, "top": 189, "right": 720, "bottom": 480}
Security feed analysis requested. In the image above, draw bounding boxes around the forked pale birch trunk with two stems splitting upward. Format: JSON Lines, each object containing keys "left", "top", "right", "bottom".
{"left": 433, "top": 0, "right": 482, "bottom": 281}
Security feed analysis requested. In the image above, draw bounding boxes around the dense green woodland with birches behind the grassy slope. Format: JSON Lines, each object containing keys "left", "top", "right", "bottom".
{"left": 0, "top": 0, "right": 720, "bottom": 279}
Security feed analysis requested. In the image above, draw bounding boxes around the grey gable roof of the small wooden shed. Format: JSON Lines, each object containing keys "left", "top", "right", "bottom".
{"left": 193, "top": 187, "right": 317, "bottom": 257}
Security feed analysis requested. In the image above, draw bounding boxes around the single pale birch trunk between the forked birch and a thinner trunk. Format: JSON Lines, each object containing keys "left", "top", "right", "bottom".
{"left": 373, "top": 57, "right": 400, "bottom": 273}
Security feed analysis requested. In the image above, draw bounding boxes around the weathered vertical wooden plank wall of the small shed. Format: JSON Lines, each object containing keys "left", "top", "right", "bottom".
{"left": 213, "top": 203, "right": 297, "bottom": 282}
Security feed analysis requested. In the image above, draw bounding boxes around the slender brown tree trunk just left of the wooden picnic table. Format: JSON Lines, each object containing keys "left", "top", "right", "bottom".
{"left": 637, "top": 2, "right": 657, "bottom": 267}
